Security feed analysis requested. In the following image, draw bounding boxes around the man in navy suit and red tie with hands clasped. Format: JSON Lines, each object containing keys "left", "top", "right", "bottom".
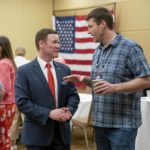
{"left": 15, "top": 29, "right": 79, "bottom": 150}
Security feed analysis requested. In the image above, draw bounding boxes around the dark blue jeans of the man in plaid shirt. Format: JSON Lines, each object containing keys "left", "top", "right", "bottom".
{"left": 94, "top": 127, "right": 138, "bottom": 150}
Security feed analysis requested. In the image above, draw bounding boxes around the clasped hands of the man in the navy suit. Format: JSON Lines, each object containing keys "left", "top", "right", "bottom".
{"left": 49, "top": 107, "right": 72, "bottom": 122}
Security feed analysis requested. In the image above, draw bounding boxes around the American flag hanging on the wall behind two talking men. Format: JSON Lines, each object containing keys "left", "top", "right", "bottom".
{"left": 55, "top": 16, "right": 97, "bottom": 76}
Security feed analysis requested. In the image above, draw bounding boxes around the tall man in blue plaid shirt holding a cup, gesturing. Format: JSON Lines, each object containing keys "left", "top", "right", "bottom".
{"left": 64, "top": 7, "right": 150, "bottom": 150}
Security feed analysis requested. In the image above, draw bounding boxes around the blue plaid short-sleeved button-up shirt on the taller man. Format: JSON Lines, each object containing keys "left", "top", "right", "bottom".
{"left": 91, "top": 34, "right": 150, "bottom": 128}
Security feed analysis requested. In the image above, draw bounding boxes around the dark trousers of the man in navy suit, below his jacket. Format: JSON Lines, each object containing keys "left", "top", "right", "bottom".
{"left": 26, "top": 122, "right": 70, "bottom": 150}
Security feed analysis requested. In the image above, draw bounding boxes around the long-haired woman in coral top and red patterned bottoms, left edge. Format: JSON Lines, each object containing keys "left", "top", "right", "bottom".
{"left": 0, "top": 36, "right": 16, "bottom": 150}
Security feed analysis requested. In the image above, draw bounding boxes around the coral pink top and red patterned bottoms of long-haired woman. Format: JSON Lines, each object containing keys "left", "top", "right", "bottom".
{"left": 0, "top": 58, "right": 16, "bottom": 150}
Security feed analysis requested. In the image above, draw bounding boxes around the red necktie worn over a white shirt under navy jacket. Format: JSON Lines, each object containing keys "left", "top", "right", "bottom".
{"left": 46, "top": 63, "right": 56, "bottom": 107}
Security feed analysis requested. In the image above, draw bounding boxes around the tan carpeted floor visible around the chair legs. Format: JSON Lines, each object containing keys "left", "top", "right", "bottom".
{"left": 18, "top": 128, "right": 96, "bottom": 150}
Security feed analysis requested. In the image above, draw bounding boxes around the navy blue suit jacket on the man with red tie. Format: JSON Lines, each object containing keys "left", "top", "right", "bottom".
{"left": 15, "top": 59, "right": 79, "bottom": 146}
